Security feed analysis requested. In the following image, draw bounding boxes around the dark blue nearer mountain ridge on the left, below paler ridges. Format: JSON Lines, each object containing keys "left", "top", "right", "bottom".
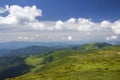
{"left": 0, "top": 46, "right": 57, "bottom": 57}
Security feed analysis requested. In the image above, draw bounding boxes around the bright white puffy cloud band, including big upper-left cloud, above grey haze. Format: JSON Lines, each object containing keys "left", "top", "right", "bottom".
{"left": 0, "top": 5, "right": 120, "bottom": 34}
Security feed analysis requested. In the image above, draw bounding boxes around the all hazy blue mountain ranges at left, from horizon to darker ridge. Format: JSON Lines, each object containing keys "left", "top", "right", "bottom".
{"left": 0, "top": 41, "right": 78, "bottom": 57}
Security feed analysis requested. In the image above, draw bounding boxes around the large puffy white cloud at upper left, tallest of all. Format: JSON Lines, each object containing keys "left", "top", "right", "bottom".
{"left": 0, "top": 5, "right": 42, "bottom": 24}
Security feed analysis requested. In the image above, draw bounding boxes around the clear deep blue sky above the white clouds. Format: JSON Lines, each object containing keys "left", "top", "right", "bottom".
{"left": 0, "top": 0, "right": 120, "bottom": 21}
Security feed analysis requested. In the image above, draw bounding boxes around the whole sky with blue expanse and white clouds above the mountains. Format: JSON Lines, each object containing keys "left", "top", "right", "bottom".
{"left": 0, "top": 0, "right": 120, "bottom": 42}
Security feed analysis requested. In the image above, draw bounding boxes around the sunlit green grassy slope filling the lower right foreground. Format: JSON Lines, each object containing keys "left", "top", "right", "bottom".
{"left": 6, "top": 46, "right": 120, "bottom": 80}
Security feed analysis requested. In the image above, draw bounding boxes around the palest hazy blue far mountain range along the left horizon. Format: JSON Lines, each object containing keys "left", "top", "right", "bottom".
{"left": 0, "top": 41, "right": 73, "bottom": 49}
